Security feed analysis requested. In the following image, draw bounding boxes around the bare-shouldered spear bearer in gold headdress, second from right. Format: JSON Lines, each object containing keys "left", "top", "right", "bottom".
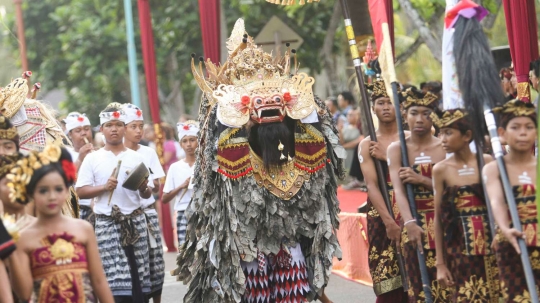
{"left": 431, "top": 108, "right": 499, "bottom": 303}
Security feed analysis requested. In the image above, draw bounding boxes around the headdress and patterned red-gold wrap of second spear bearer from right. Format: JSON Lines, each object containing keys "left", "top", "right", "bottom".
{"left": 431, "top": 109, "right": 500, "bottom": 303}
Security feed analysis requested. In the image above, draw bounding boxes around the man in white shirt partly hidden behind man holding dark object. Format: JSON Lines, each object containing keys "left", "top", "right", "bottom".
{"left": 122, "top": 104, "right": 165, "bottom": 303}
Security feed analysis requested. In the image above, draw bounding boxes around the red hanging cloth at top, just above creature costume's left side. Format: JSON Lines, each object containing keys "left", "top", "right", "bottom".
{"left": 199, "top": 0, "right": 220, "bottom": 63}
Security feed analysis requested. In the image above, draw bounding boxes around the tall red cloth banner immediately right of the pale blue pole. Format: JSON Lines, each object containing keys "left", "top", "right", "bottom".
{"left": 137, "top": 0, "right": 161, "bottom": 123}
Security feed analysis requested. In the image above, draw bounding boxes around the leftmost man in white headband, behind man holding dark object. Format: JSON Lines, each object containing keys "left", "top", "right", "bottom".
{"left": 64, "top": 112, "right": 95, "bottom": 226}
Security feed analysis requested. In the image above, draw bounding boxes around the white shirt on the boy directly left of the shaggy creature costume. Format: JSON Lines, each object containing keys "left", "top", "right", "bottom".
{"left": 163, "top": 159, "right": 195, "bottom": 211}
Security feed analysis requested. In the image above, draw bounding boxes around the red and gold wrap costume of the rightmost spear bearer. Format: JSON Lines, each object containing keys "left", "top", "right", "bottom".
{"left": 496, "top": 184, "right": 540, "bottom": 302}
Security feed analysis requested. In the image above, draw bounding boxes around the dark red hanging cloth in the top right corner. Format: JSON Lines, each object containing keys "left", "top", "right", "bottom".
{"left": 503, "top": 0, "right": 538, "bottom": 100}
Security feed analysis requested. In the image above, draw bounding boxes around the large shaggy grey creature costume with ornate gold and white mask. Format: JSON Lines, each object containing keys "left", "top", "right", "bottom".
{"left": 173, "top": 19, "right": 345, "bottom": 303}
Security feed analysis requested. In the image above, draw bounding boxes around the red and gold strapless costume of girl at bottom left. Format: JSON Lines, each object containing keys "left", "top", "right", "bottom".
{"left": 30, "top": 233, "right": 97, "bottom": 303}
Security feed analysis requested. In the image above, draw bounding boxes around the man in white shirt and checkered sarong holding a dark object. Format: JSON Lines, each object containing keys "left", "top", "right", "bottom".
{"left": 75, "top": 103, "right": 152, "bottom": 303}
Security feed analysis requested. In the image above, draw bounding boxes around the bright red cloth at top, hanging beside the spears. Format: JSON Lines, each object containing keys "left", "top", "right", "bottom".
{"left": 368, "top": 0, "right": 395, "bottom": 56}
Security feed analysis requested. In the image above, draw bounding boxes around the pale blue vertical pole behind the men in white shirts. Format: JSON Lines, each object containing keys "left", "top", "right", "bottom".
{"left": 124, "top": 0, "right": 141, "bottom": 107}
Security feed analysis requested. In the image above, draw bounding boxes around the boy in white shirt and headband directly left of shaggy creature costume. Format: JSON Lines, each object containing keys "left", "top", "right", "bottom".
{"left": 162, "top": 120, "right": 199, "bottom": 246}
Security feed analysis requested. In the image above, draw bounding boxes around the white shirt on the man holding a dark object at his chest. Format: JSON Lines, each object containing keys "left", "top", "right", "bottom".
{"left": 75, "top": 148, "right": 150, "bottom": 216}
